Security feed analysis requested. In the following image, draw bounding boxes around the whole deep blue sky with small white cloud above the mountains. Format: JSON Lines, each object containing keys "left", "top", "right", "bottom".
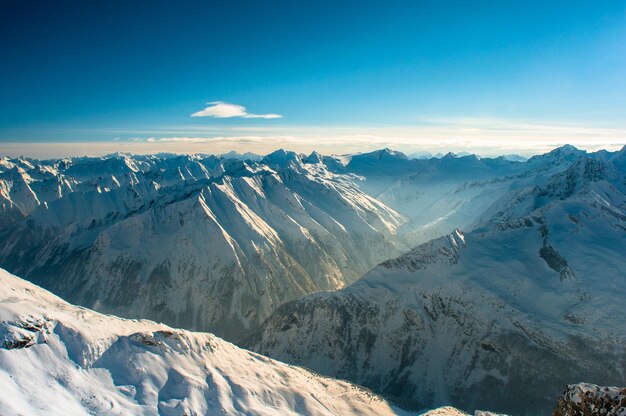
{"left": 0, "top": 0, "right": 626, "bottom": 157}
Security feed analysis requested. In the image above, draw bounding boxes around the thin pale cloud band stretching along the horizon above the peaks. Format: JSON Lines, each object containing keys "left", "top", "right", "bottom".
{"left": 0, "top": 117, "right": 626, "bottom": 158}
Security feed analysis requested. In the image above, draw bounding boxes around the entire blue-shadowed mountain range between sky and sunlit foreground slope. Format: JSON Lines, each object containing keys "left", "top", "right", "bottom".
{"left": 0, "top": 146, "right": 626, "bottom": 415}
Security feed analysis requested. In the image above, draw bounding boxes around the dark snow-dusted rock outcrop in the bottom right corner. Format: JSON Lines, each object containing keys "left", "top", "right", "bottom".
{"left": 552, "top": 383, "right": 626, "bottom": 416}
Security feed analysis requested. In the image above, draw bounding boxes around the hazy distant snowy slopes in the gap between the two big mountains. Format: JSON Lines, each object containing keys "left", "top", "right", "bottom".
{"left": 324, "top": 145, "right": 614, "bottom": 244}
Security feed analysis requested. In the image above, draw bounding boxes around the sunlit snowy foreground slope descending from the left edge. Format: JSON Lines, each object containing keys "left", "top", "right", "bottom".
{"left": 0, "top": 270, "right": 416, "bottom": 416}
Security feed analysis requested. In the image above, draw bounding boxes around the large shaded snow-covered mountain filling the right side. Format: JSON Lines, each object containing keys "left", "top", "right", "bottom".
{"left": 247, "top": 148, "right": 626, "bottom": 415}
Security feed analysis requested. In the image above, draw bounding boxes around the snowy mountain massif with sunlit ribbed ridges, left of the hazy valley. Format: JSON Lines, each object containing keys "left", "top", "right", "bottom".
{"left": 0, "top": 151, "right": 406, "bottom": 339}
